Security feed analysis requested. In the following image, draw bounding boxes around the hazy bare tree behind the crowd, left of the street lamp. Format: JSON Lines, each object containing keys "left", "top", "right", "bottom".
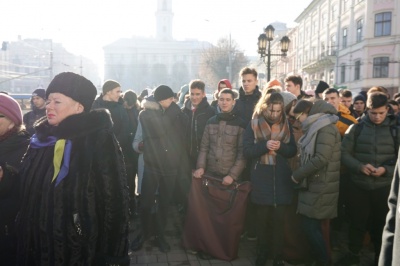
{"left": 199, "top": 37, "right": 249, "bottom": 89}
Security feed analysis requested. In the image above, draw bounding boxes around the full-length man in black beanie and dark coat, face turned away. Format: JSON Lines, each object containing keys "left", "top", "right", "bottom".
{"left": 139, "top": 85, "right": 188, "bottom": 252}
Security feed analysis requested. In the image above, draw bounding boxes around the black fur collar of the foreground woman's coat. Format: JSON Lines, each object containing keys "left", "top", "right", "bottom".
{"left": 35, "top": 109, "right": 113, "bottom": 140}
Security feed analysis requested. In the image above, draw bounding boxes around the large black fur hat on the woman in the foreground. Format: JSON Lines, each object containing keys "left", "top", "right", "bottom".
{"left": 46, "top": 72, "right": 97, "bottom": 112}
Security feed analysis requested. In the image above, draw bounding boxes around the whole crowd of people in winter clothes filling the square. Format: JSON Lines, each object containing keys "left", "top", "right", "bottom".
{"left": 0, "top": 67, "right": 400, "bottom": 266}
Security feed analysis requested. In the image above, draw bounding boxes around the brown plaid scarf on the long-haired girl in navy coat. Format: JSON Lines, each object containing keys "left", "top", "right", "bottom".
{"left": 251, "top": 114, "right": 290, "bottom": 165}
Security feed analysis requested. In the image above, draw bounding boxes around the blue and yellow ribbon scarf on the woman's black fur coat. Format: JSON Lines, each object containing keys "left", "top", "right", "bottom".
{"left": 30, "top": 134, "right": 72, "bottom": 186}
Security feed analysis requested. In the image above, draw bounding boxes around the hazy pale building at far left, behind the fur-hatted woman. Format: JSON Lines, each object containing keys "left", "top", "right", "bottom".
{"left": 0, "top": 38, "right": 100, "bottom": 93}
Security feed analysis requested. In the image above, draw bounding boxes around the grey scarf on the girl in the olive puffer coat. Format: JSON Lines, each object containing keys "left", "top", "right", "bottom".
{"left": 298, "top": 113, "right": 339, "bottom": 165}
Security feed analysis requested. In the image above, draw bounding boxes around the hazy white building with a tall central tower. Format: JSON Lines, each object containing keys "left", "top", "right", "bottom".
{"left": 104, "top": 0, "right": 211, "bottom": 92}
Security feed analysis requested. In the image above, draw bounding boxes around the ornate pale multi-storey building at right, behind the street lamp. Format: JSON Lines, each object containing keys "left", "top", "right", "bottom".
{"left": 272, "top": 0, "right": 400, "bottom": 94}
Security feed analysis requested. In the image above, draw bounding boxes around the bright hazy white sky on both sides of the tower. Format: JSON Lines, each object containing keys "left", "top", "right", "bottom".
{"left": 0, "top": 0, "right": 312, "bottom": 63}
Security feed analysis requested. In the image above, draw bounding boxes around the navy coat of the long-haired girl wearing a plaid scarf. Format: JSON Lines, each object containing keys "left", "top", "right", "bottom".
{"left": 243, "top": 120, "right": 297, "bottom": 206}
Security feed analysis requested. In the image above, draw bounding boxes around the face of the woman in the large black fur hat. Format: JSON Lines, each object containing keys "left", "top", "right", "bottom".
{"left": 46, "top": 93, "right": 84, "bottom": 126}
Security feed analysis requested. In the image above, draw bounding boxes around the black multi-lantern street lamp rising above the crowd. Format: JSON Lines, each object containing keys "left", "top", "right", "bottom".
{"left": 258, "top": 25, "right": 290, "bottom": 81}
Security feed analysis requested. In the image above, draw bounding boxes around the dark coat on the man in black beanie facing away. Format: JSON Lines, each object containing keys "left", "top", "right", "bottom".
{"left": 139, "top": 101, "right": 189, "bottom": 173}
